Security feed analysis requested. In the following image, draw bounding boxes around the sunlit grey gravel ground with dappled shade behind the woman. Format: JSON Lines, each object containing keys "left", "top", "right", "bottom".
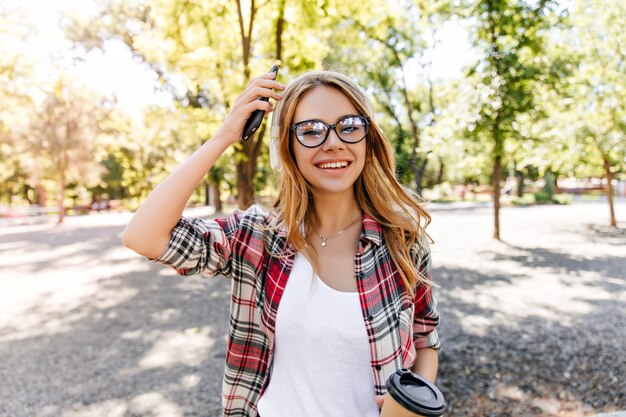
{"left": 0, "top": 201, "right": 626, "bottom": 417}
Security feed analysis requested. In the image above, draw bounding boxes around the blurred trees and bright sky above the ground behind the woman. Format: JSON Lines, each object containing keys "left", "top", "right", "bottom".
{"left": 0, "top": 0, "right": 626, "bottom": 237}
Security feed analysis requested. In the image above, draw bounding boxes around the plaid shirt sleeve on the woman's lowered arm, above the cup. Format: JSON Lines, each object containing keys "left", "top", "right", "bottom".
{"left": 413, "top": 239, "right": 441, "bottom": 350}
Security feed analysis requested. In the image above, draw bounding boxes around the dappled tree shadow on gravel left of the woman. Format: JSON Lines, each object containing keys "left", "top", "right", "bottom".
{"left": 0, "top": 223, "right": 230, "bottom": 417}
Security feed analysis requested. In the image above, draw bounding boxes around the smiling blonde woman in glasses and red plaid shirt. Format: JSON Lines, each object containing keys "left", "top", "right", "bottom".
{"left": 123, "top": 71, "right": 440, "bottom": 417}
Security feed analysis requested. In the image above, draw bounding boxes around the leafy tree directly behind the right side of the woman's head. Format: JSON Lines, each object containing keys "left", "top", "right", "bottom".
{"left": 325, "top": 1, "right": 450, "bottom": 195}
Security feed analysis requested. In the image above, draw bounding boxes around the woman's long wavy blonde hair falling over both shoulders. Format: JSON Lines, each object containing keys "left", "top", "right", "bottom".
{"left": 266, "top": 71, "right": 432, "bottom": 296}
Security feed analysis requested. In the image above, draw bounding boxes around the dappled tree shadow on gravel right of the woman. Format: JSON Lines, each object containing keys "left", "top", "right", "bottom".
{"left": 433, "top": 240, "right": 626, "bottom": 417}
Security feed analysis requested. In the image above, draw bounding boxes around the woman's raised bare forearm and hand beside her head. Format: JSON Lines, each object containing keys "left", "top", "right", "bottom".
{"left": 122, "top": 74, "right": 285, "bottom": 258}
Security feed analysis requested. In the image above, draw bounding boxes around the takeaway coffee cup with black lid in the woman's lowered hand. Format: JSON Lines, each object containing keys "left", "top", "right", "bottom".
{"left": 380, "top": 368, "right": 446, "bottom": 417}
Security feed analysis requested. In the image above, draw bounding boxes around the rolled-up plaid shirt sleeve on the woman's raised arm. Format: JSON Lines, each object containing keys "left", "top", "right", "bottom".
{"left": 151, "top": 206, "right": 265, "bottom": 277}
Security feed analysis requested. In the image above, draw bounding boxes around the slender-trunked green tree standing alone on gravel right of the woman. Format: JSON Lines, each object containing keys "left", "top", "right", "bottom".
{"left": 469, "top": 0, "right": 558, "bottom": 240}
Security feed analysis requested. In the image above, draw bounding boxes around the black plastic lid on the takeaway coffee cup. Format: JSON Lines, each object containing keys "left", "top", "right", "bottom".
{"left": 387, "top": 368, "right": 446, "bottom": 417}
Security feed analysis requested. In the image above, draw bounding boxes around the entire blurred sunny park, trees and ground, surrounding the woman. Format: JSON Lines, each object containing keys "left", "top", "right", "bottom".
{"left": 0, "top": 0, "right": 626, "bottom": 417}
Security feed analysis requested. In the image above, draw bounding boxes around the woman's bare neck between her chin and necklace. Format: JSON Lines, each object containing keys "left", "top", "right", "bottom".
{"left": 313, "top": 194, "right": 361, "bottom": 236}
